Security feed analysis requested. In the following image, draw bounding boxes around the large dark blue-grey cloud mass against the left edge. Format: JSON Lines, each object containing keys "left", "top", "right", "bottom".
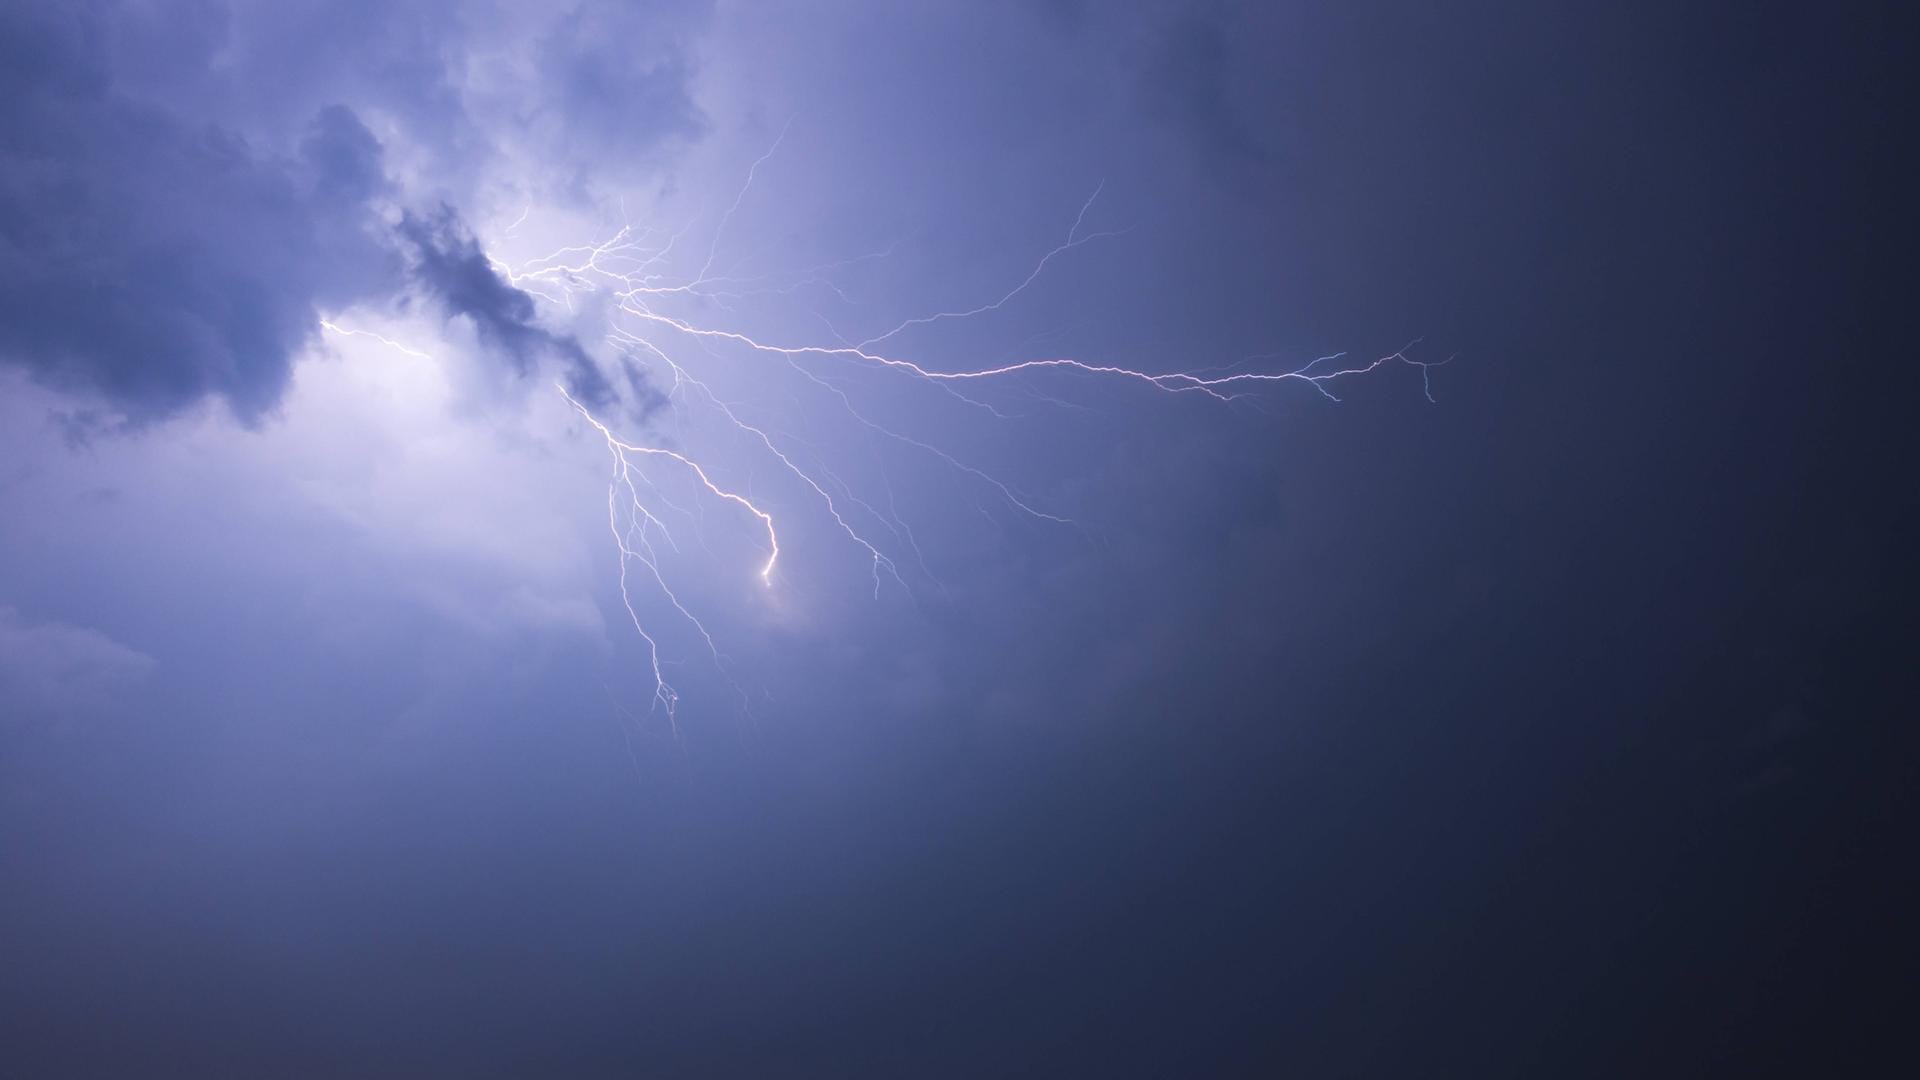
{"left": 0, "top": 8, "right": 396, "bottom": 421}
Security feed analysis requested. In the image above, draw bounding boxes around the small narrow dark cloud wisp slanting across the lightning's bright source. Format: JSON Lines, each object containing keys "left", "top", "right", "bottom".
{"left": 399, "top": 206, "right": 612, "bottom": 405}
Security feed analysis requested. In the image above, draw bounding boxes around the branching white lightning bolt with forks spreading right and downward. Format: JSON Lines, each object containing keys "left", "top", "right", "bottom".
{"left": 468, "top": 141, "right": 1453, "bottom": 722}
